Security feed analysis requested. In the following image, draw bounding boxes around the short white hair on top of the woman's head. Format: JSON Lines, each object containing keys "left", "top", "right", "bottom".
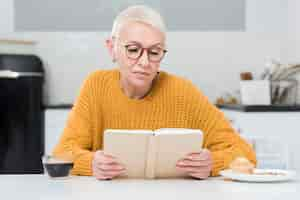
{"left": 111, "top": 5, "right": 166, "bottom": 37}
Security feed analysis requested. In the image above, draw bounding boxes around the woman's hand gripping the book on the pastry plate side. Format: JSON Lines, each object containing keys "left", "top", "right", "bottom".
{"left": 176, "top": 149, "right": 212, "bottom": 179}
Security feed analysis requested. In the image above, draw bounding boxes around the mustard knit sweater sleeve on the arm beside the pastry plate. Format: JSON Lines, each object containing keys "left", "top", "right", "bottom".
{"left": 191, "top": 85, "right": 256, "bottom": 176}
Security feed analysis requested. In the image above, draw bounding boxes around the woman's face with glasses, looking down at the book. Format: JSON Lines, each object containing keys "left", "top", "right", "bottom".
{"left": 114, "top": 22, "right": 165, "bottom": 87}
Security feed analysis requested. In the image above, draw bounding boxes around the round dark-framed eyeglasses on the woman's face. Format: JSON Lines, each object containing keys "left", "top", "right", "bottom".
{"left": 124, "top": 43, "right": 167, "bottom": 62}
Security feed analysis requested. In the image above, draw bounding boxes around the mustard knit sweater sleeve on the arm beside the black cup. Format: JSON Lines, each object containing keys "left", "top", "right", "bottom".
{"left": 53, "top": 74, "right": 94, "bottom": 176}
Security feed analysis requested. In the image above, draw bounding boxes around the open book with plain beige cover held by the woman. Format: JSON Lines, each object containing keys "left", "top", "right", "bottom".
{"left": 103, "top": 128, "right": 202, "bottom": 178}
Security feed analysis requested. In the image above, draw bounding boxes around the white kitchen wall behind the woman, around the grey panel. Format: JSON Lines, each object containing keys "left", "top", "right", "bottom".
{"left": 0, "top": 0, "right": 297, "bottom": 104}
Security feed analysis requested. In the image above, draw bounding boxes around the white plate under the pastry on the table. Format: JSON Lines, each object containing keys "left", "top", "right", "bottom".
{"left": 220, "top": 169, "right": 296, "bottom": 182}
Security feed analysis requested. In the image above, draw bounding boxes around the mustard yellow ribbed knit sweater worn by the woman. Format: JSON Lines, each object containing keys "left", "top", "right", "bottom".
{"left": 53, "top": 69, "right": 256, "bottom": 176}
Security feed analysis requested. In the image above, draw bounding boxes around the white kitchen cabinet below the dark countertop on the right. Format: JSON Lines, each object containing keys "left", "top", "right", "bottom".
{"left": 222, "top": 109, "right": 300, "bottom": 170}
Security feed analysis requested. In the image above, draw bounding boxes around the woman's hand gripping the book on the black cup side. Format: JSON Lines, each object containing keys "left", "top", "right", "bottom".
{"left": 92, "top": 151, "right": 126, "bottom": 180}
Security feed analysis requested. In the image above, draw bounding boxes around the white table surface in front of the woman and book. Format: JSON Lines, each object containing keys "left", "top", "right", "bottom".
{"left": 0, "top": 175, "right": 300, "bottom": 200}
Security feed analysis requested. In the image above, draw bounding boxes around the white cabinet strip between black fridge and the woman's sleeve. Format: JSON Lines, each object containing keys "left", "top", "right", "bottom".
{"left": 45, "top": 109, "right": 70, "bottom": 154}
